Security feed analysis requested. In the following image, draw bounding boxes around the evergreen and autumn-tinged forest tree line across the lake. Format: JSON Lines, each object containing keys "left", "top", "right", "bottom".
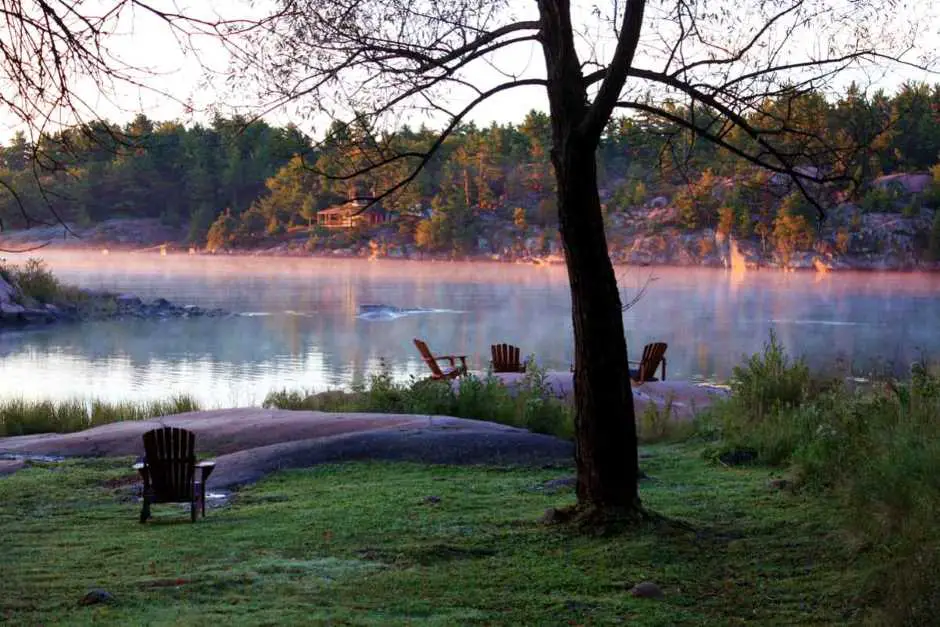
{"left": 0, "top": 83, "right": 940, "bottom": 250}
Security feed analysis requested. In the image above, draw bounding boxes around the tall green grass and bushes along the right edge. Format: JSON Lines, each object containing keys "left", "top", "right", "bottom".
{"left": 698, "top": 336, "right": 940, "bottom": 625}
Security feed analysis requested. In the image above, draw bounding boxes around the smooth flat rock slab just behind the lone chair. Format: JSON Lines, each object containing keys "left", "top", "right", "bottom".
{"left": 0, "top": 409, "right": 574, "bottom": 490}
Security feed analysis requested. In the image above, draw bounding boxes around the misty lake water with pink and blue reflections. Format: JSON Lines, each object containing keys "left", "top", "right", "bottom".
{"left": 0, "top": 253, "right": 940, "bottom": 407}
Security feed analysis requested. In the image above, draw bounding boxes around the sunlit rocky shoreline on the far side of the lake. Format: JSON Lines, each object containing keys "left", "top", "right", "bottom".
{"left": 0, "top": 205, "right": 940, "bottom": 272}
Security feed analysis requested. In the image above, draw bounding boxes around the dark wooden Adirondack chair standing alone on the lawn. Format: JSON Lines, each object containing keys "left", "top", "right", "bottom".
{"left": 134, "top": 427, "right": 215, "bottom": 523}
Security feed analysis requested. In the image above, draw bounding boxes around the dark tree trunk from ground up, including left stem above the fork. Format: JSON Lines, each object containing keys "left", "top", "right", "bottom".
{"left": 539, "top": 0, "right": 640, "bottom": 514}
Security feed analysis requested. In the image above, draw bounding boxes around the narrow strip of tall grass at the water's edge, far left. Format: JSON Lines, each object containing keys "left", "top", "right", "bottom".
{"left": 0, "top": 395, "right": 199, "bottom": 436}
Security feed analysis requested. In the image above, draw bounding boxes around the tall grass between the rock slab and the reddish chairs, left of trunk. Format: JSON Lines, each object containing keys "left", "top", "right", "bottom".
{"left": 263, "top": 364, "right": 574, "bottom": 438}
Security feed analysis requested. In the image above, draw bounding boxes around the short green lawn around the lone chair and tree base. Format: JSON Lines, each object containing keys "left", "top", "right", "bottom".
{"left": 0, "top": 444, "right": 862, "bottom": 626}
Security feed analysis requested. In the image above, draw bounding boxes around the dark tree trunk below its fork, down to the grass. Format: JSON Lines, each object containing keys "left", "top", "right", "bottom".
{"left": 556, "top": 136, "right": 639, "bottom": 510}
